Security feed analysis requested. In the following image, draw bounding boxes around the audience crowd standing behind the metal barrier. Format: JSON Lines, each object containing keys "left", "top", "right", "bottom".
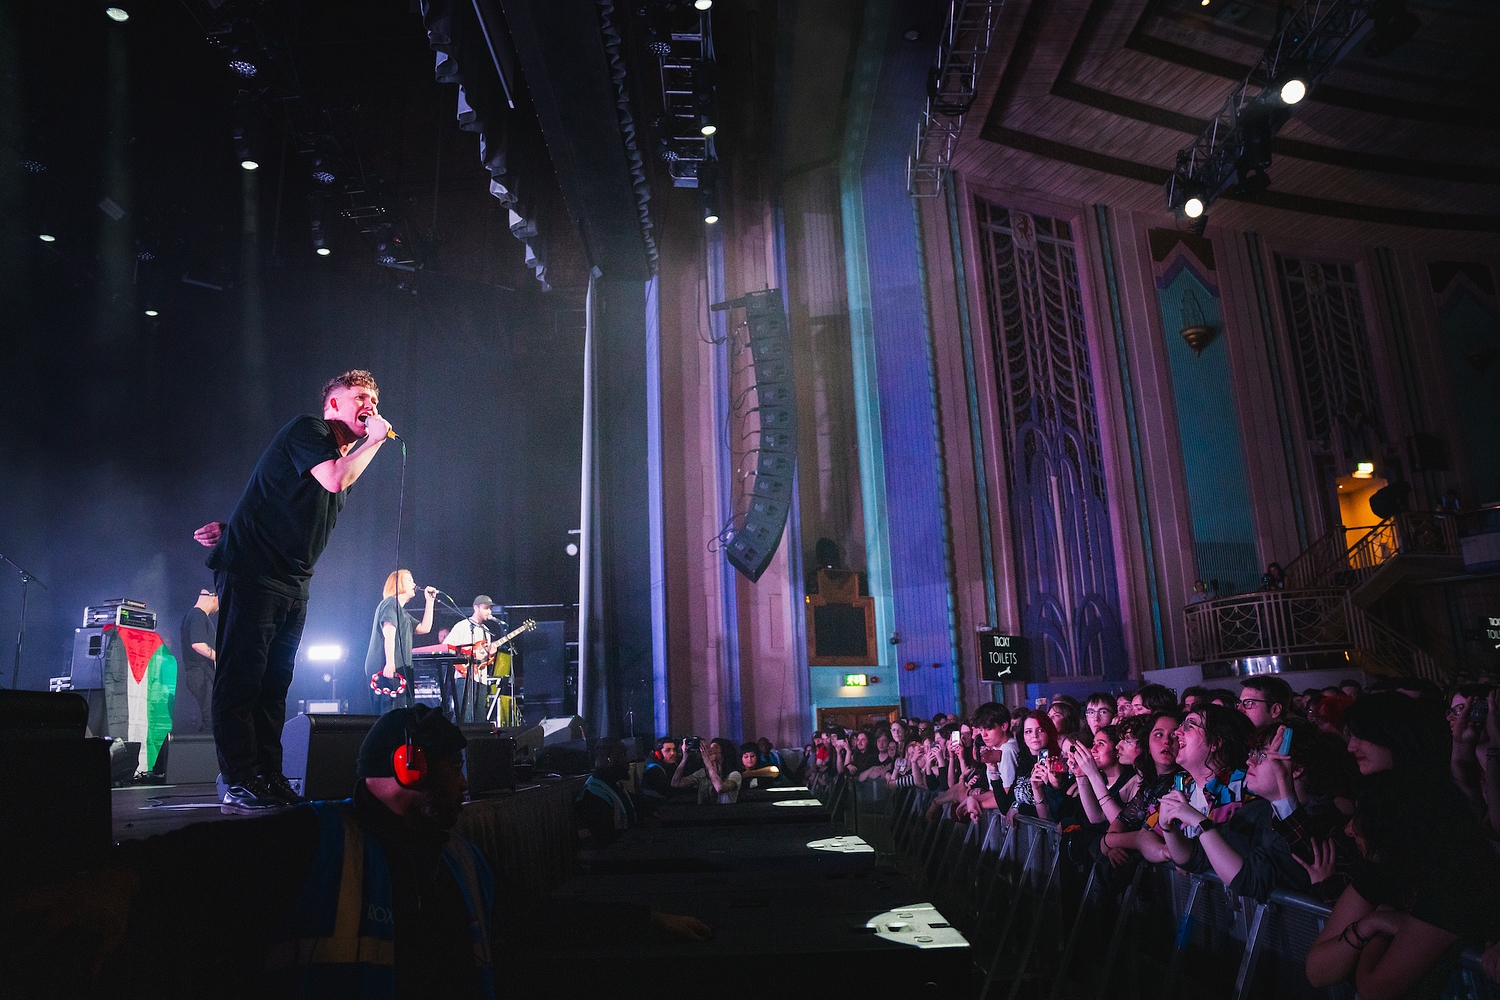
{"left": 786, "top": 675, "right": 1500, "bottom": 1000}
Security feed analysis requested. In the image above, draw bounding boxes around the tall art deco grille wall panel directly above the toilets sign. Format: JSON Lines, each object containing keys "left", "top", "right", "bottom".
{"left": 975, "top": 199, "right": 1127, "bottom": 689}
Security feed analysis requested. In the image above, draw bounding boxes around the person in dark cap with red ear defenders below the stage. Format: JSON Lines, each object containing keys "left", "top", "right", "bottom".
{"left": 0, "top": 705, "right": 713, "bottom": 999}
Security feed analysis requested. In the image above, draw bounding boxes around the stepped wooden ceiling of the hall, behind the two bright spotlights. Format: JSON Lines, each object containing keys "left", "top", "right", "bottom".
{"left": 959, "top": 0, "right": 1500, "bottom": 231}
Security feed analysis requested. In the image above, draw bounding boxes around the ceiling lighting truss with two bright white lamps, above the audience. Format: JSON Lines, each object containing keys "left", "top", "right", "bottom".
{"left": 1167, "top": 0, "right": 1421, "bottom": 225}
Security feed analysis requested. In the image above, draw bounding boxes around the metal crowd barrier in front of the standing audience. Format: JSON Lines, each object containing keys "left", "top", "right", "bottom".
{"left": 827, "top": 780, "right": 1500, "bottom": 1000}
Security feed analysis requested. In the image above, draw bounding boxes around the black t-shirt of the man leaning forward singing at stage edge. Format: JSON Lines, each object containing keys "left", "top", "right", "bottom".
{"left": 209, "top": 417, "right": 350, "bottom": 600}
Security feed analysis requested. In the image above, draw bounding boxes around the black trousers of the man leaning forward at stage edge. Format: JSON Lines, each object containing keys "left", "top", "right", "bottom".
{"left": 213, "top": 573, "right": 308, "bottom": 784}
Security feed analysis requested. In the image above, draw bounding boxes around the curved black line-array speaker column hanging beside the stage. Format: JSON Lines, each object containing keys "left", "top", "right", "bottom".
{"left": 713, "top": 288, "right": 797, "bottom": 582}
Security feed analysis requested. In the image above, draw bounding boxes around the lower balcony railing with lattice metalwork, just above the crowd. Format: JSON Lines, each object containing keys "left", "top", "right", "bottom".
{"left": 1184, "top": 588, "right": 1445, "bottom": 684}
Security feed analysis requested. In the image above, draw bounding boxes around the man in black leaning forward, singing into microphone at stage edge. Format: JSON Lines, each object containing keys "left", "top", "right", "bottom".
{"left": 194, "top": 369, "right": 392, "bottom": 816}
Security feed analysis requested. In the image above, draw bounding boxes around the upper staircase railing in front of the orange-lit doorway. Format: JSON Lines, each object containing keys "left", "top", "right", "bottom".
{"left": 1287, "top": 511, "right": 1463, "bottom": 589}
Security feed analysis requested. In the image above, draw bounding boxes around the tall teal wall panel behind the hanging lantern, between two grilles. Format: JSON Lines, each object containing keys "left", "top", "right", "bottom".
{"left": 1157, "top": 255, "right": 1260, "bottom": 595}
